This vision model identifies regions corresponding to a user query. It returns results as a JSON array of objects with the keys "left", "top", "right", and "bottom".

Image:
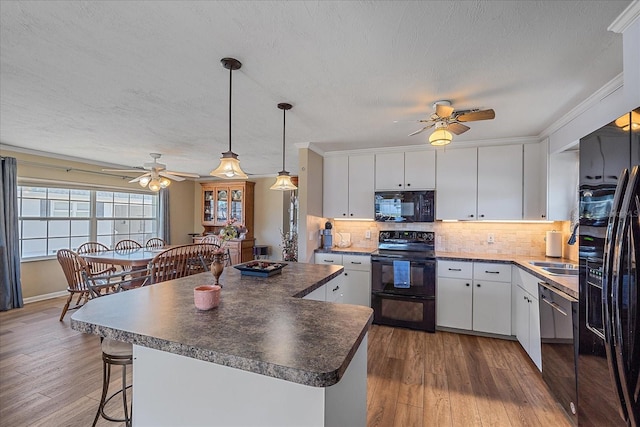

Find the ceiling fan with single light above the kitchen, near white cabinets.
[{"left": 409, "top": 101, "right": 496, "bottom": 145}]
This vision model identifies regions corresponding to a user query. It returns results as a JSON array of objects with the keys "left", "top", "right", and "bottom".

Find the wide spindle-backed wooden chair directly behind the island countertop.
[{"left": 149, "top": 243, "right": 220, "bottom": 283}]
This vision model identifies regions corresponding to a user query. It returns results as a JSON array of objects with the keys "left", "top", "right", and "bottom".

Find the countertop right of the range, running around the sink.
[{"left": 436, "top": 252, "right": 578, "bottom": 299}]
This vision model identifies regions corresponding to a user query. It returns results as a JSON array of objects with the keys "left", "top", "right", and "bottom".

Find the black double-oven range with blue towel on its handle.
[{"left": 371, "top": 231, "right": 436, "bottom": 332}]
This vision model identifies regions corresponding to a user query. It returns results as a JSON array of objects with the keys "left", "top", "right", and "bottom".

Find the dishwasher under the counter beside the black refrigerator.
[{"left": 538, "top": 282, "right": 578, "bottom": 424}]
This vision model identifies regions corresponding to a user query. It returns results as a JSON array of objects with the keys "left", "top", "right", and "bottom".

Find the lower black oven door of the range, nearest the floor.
[{"left": 371, "top": 292, "right": 436, "bottom": 332}]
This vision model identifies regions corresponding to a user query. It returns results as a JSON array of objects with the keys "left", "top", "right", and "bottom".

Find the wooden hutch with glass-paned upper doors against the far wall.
[{"left": 193, "top": 181, "right": 256, "bottom": 264}]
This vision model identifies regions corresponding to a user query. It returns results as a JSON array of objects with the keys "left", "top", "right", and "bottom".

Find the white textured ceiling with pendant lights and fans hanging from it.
[{"left": 0, "top": 0, "right": 630, "bottom": 175}]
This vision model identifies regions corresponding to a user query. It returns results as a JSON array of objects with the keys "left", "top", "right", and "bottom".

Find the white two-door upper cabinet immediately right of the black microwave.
[{"left": 436, "top": 144, "right": 523, "bottom": 220}]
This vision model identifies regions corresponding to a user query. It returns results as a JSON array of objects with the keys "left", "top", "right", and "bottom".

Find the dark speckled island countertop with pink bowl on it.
[{"left": 71, "top": 263, "right": 373, "bottom": 387}]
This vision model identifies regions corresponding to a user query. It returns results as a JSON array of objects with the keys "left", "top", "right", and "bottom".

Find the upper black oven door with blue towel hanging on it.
[{"left": 371, "top": 258, "right": 436, "bottom": 298}]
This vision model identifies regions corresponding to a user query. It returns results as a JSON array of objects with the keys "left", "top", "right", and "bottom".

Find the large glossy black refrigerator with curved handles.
[{"left": 576, "top": 108, "right": 640, "bottom": 426}]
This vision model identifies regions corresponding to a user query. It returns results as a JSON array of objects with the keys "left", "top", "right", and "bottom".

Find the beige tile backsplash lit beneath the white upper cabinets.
[{"left": 333, "top": 221, "right": 578, "bottom": 260}]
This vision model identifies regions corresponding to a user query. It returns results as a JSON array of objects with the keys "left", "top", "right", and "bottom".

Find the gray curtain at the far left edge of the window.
[{"left": 0, "top": 157, "right": 24, "bottom": 311}]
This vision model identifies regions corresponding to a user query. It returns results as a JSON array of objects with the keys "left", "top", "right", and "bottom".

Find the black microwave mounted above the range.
[{"left": 375, "top": 191, "right": 435, "bottom": 223}]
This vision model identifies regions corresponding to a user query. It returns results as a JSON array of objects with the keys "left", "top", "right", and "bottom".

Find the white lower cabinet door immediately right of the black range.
[{"left": 436, "top": 277, "right": 473, "bottom": 330}]
